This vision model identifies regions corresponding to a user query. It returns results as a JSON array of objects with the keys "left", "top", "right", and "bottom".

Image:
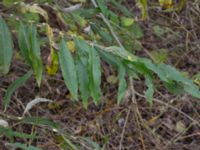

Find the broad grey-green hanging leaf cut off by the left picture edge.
[{"left": 0, "top": 17, "right": 13, "bottom": 75}]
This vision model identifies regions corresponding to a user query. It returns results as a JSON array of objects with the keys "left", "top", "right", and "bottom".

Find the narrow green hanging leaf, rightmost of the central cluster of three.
[{"left": 89, "top": 47, "right": 101, "bottom": 104}]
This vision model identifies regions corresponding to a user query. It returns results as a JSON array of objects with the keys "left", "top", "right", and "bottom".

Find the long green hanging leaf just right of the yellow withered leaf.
[{"left": 58, "top": 40, "right": 78, "bottom": 100}]
